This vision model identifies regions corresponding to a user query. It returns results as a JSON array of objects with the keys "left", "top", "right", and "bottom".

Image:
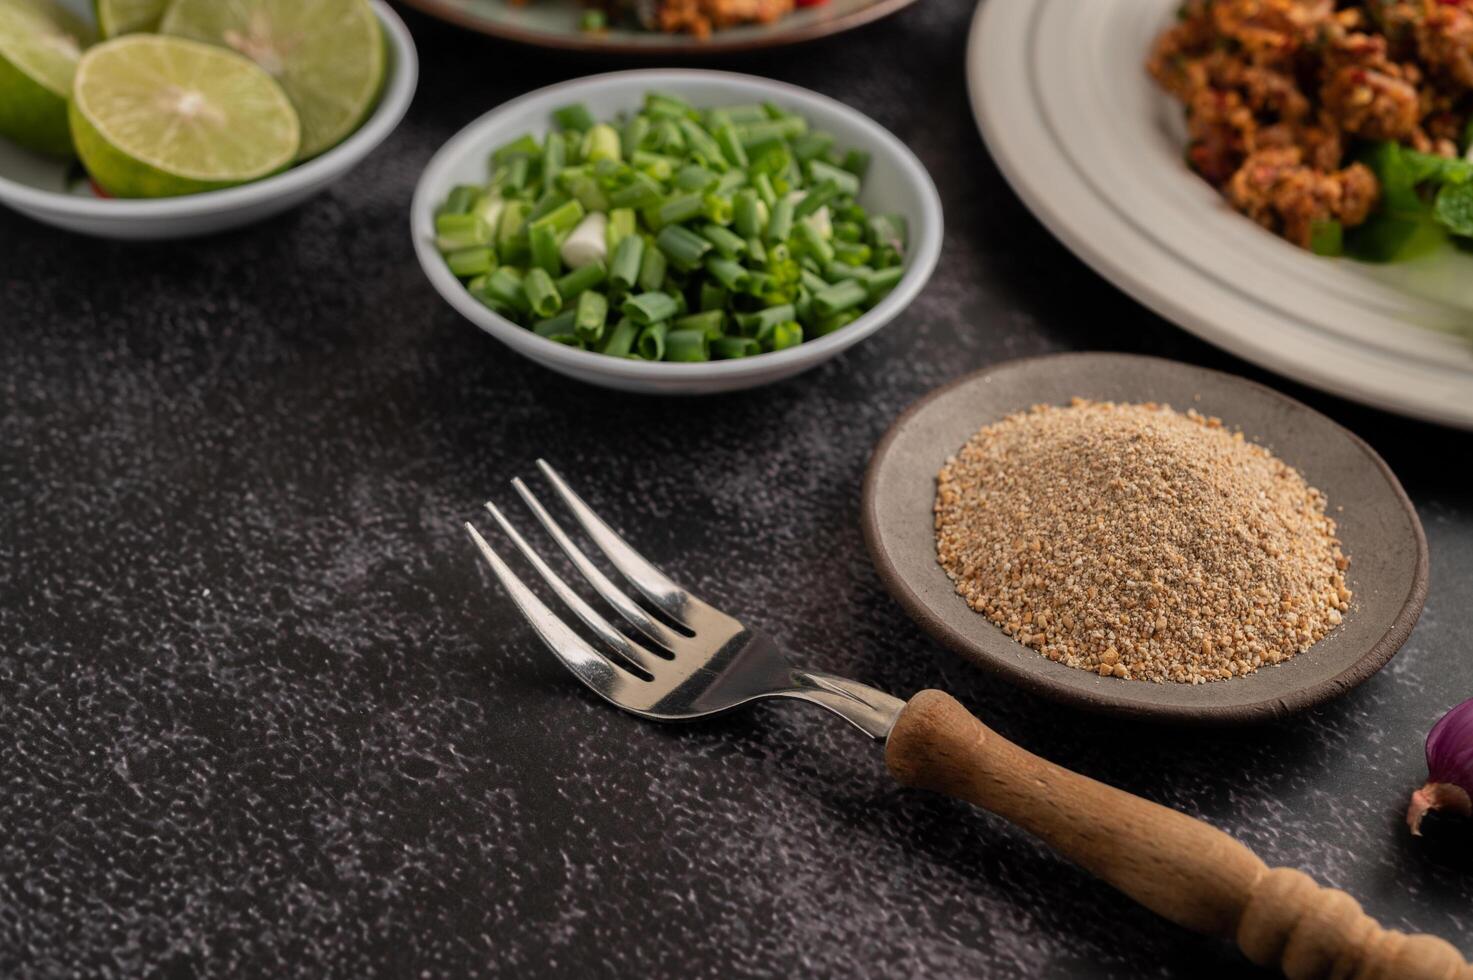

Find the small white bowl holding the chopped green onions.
[{"left": 409, "top": 69, "right": 941, "bottom": 395}]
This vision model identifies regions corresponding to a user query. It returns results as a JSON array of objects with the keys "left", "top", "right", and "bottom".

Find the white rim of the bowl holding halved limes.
[{"left": 0, "top": 0, "right": 420, "bottom": 220}]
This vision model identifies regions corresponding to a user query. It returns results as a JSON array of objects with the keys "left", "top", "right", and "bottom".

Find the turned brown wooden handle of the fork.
[{"left": 885, "top": 691, "right": 1473, "bottom": 980}]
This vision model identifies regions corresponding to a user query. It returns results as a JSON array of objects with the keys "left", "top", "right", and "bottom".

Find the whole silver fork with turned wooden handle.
[{"left": 465, "top": 460, "right": 1473, "bottom": 980}]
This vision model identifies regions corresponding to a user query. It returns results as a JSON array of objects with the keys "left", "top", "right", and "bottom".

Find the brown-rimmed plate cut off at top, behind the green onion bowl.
[{"left": 405, "top": 0, "right": 915, "bottom": 57}]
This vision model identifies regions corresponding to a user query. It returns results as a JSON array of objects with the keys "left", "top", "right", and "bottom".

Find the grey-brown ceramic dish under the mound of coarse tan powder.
[{"left": 862, "top": 354, "right": 1427, "bottom": 724}]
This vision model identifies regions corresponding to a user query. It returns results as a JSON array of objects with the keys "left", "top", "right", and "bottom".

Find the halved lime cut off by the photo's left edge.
[{"left": 0, "top": 0, "right": 93, "bottom": 156}]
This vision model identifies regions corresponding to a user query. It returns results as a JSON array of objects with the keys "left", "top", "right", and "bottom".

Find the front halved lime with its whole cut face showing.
[{"left": 71, "top": 34, "right": 302, "bottom": 197}]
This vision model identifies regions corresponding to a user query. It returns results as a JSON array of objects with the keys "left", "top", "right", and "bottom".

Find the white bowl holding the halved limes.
[{"left": 0, "top": 0, "right": 420, "bottom": 239}]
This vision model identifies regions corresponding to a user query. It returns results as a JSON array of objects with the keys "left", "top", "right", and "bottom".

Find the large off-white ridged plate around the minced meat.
[{"left": 966, "top": 0, "right": 1473, "bottom": 429}]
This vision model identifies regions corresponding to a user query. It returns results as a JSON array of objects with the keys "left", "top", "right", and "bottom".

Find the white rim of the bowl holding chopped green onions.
[{"left": 409, "top": 68, "right": 944, "bottom": 380}]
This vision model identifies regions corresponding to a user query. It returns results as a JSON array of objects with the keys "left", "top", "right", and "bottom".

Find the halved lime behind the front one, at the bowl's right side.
[{"left": 161, "top": 0, "right": 387, "bottom": 159}]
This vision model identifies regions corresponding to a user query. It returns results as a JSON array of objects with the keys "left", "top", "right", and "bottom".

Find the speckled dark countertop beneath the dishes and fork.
[{"left": 0, "top": 0, "right": 1473, "bottom": 977}]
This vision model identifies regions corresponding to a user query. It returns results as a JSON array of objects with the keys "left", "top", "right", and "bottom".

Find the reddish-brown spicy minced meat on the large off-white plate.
[{"left": 1147, "top": 0, "right": 1473, "bottom": 258}]
